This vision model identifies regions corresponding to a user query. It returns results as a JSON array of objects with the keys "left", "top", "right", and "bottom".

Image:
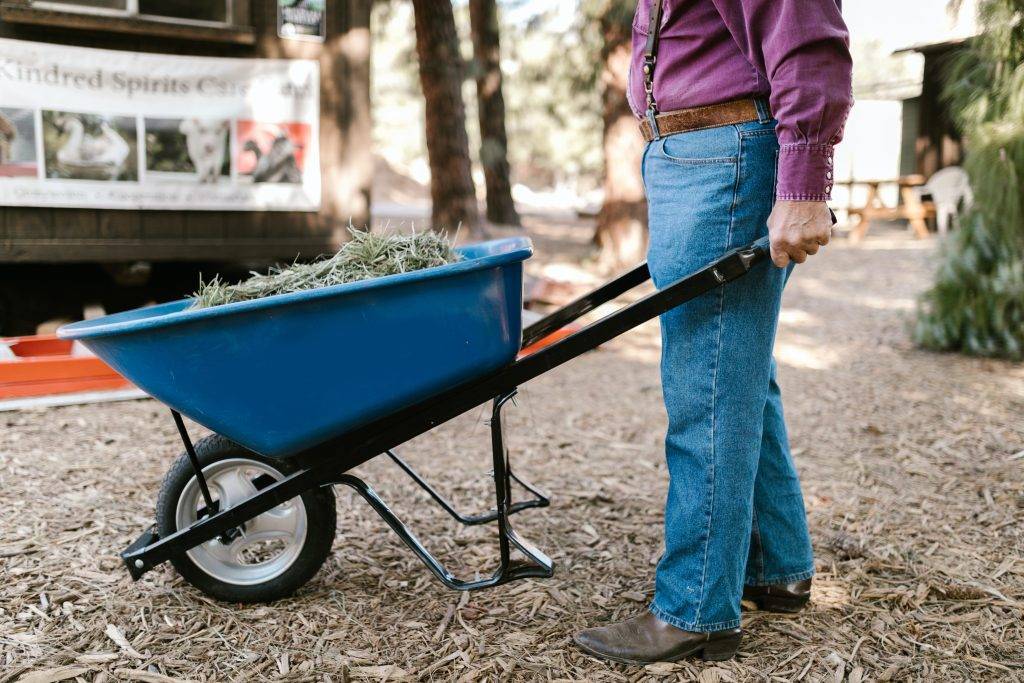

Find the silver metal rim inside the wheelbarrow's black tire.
[{"left": 175, "top": 458, "right": 307, "bottom": 586}]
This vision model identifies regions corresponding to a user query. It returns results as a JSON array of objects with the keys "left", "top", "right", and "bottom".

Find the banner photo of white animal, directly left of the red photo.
[{"left": 144, "top": 119, "right": 231, "bottom": 183}]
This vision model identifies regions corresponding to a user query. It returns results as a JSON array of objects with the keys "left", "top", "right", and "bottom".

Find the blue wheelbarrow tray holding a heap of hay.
[{"left": 58, "top": 238, "right": 532, "bottom": 457}]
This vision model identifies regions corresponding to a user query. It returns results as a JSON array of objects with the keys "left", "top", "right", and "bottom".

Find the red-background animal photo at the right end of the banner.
[{"left": 236, "top": 121, "right": 309, "bottom": 184}]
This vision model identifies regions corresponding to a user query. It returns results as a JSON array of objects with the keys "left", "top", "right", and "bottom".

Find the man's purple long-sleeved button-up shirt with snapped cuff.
[{"left": 629, "top": 0, "right": 853, "bottom": 201}]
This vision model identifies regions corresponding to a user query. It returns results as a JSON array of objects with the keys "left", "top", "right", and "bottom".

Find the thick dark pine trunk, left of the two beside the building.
[{"left": 413, "top": 0, "right": 479, "bottom": 234}]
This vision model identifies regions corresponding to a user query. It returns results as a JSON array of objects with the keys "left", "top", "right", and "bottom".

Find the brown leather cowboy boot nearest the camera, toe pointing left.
[{"left": 573, "top": 611, "right": 743, "bottom": 665}]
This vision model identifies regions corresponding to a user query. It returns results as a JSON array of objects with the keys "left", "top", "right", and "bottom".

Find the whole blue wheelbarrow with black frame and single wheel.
[{"left": 58, "top": 238, "right": 768, "bottom": 602}]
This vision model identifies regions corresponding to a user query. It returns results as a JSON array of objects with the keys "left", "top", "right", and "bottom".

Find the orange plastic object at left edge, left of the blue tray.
[{"left": 0, "top": 335, "right": 131, "bottom": 399}]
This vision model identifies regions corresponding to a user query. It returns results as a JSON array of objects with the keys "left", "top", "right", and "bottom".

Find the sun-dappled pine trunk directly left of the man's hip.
[{"left": 594, "top": 12, "right": 647, "bottom": 269}]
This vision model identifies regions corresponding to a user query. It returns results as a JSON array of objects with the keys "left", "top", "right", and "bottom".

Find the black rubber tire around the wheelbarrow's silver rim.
[{"left": 157, "top": 434, "right": 337, "bottom": 603}]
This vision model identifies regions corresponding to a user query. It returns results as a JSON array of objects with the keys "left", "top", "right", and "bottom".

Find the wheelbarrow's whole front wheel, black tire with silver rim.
[{"left": 157, "top": 434, "right": 337, "bottom": 602}]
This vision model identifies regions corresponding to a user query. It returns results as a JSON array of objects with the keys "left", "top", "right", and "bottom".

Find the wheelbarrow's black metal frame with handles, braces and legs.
[{"left": 121, "top": 240, "right": 768, "bottom": 591}]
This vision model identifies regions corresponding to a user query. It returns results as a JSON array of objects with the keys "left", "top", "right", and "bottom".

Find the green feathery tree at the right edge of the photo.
[{"left": 914, "top": 0, "right": 1024, "bottom": 359}]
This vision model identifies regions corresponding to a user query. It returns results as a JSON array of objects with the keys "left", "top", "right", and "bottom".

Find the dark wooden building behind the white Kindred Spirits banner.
[{"left": 0, "top": 0, "right": 372, "bottom": 264}]
